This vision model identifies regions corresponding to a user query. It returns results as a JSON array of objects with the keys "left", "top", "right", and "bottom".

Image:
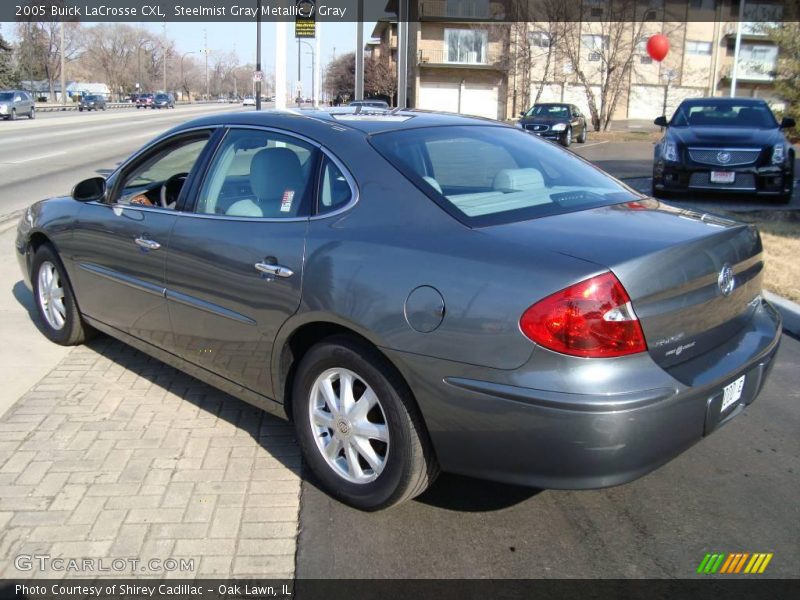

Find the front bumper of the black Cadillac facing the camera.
[{"left": 653, "top": 163, "right": 793, "bottom": 195}]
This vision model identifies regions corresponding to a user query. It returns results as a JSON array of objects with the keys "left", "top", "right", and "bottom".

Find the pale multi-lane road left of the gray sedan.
[{"left": 0, "top": 104, "right": 252, "bottom": 217}]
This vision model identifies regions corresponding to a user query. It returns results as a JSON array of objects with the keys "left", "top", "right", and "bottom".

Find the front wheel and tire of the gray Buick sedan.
[{"left": 31, "top": 244, "right": 92, "bottom": 346}]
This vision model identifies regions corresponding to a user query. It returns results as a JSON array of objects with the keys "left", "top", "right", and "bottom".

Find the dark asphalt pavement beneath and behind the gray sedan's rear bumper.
[{"left": 297, "top": 337, "right": 800, "bottom": 579}]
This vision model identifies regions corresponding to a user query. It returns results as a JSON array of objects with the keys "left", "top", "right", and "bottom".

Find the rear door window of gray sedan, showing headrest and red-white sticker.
[{"left": 196, "top": 129, "right": 317, "bottom": 219}]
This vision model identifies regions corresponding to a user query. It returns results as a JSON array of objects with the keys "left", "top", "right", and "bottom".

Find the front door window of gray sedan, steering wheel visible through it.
[{"left": 112, "top": 132, "right": 210, "bottom": 209}]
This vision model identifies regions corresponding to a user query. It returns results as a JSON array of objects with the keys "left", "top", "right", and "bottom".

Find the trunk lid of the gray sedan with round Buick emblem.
[{"left": 484, "top": 200, "right": 763, "bottom": 368}]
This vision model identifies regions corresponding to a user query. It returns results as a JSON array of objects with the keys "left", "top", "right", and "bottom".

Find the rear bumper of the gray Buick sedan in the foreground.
[{"left": 387, "top": 301, "right": 780, "bottom": 489}]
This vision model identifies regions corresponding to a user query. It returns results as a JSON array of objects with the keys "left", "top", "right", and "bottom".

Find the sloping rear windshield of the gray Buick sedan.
[{"left": 370, "top": 126, "right": 639, "bottom": 227}]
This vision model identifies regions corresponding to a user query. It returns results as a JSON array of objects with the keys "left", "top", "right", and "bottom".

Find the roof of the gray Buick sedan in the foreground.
[{"left": 177, "top": 108, "right": 510, "bottom": 135}]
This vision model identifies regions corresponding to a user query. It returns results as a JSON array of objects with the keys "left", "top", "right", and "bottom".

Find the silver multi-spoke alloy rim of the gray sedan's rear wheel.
[{"left": 308, "top": 368, "right": 390, "bottom": 484}]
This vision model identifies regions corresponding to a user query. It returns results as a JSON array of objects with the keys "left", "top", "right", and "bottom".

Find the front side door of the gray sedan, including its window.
[{"left": 71, "top": 129, "right": 217, "bottom": 349}]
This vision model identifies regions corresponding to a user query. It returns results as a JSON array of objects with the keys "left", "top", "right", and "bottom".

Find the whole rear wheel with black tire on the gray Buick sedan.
[{"left": 292, "top": 336, "right": 439, "bottom": 510}]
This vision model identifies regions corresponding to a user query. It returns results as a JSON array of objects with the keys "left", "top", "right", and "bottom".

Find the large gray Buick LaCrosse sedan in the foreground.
[{"left": 15, "top": 111, "right": 781, "bottom": 509}]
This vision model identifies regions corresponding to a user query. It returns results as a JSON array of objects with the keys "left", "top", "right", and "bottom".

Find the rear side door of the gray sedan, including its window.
[{"left": 167, "top": 128, "right": 319, "bottom": 397}]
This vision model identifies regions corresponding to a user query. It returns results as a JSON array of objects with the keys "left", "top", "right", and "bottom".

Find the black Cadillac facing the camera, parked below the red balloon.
[{"left": 653, "top": 98, "right": 795, "bottom": 203}]
